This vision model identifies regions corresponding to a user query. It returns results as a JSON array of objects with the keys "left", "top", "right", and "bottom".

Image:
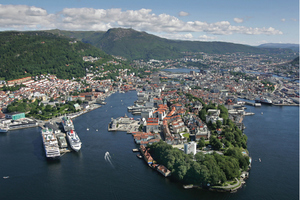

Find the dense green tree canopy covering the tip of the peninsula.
[{"left": 149, "top": 141, "right": 249, "bottom": 186}]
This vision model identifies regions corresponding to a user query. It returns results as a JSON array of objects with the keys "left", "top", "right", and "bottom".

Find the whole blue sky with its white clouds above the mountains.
[{"left": 0, "top": 0, "right": 299, "bottom": 45}]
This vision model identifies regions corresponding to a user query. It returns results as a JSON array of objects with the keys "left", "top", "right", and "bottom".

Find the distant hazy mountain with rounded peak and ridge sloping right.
[{"left": 50, "top": 28, "right": 289, "bottom": 60}]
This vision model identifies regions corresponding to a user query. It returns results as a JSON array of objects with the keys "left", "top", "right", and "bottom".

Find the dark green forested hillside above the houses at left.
[{"left": 0, "top": 31, "right": 112, "bottom": 80}]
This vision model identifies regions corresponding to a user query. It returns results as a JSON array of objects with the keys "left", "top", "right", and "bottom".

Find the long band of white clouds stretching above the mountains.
[{"left": 0, "top": 4, "right": 283, "bottom": 36}]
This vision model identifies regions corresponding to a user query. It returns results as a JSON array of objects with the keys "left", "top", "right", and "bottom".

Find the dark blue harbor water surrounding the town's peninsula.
[{"left": 0, "top": 91, "right": 299, "bottom": 200}]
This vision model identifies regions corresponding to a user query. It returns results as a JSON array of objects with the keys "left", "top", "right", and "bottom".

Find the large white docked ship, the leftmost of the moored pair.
[{"left": 41, "top": 128, "right": 60, "bottom": 159}]
